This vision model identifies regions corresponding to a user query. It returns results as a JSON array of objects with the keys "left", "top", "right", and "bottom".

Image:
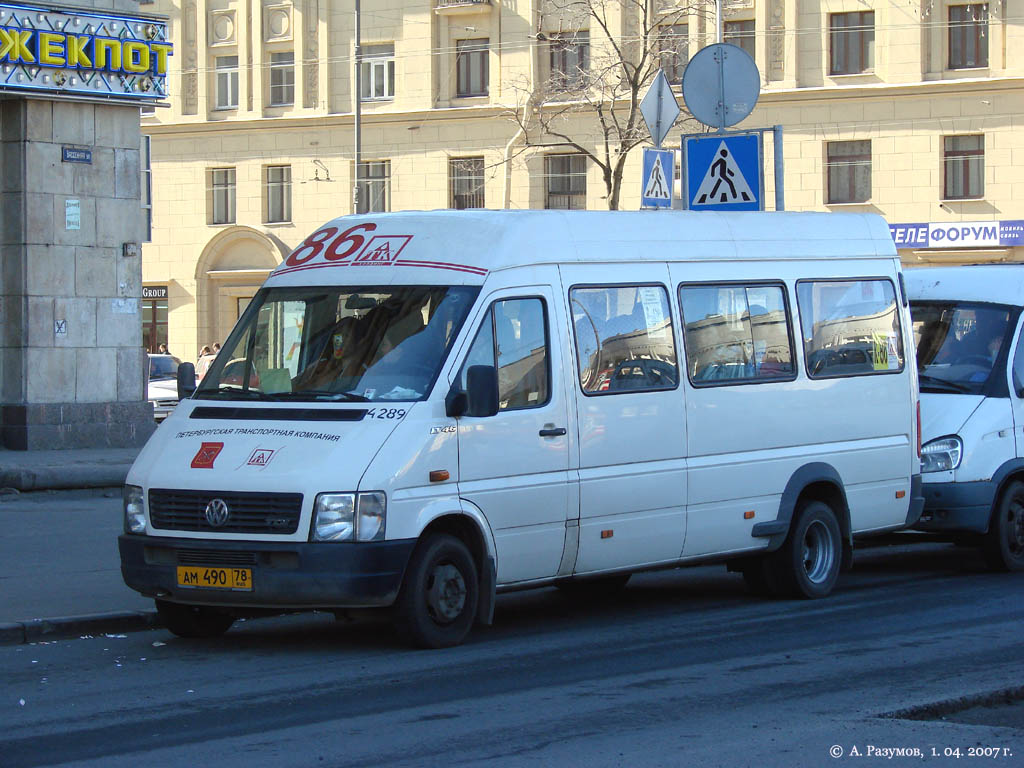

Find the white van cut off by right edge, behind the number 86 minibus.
[{"left": 906, "top": 264, "right": 1024, "bottom": 570}]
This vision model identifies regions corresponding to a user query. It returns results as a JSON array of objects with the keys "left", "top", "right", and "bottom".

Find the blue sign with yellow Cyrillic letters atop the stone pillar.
[{"left": 0, "top": 3, "right": 173, "bottom": 100}]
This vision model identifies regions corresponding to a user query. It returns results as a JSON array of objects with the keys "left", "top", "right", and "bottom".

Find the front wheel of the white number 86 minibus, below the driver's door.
[{"left": 395, "top": 534, "right": 479, "bottom": 648}]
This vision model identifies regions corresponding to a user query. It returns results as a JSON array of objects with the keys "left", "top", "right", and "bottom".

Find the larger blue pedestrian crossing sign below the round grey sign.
[{"left": 683, "top": 132, "right": 764, "bottom": 211}]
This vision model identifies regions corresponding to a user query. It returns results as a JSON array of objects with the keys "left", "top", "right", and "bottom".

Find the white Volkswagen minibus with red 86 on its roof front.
[{"left": 120, "top": 211, "right": 922, "bottom": 647}]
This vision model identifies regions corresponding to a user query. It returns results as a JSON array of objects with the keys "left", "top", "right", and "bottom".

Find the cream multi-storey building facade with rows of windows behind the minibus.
[{"left": 142, "top": 0, "right": 1024, "bottom": 359}]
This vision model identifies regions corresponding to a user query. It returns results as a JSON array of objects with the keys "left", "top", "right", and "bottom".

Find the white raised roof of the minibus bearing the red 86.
[{"left": 269, "top": 210, "right": 896, "bottom": 286}]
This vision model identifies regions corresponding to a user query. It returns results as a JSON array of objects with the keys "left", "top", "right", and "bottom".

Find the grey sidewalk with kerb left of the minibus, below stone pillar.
[{"left": 0, "top": 449, "right": 156, "bottom": 645}]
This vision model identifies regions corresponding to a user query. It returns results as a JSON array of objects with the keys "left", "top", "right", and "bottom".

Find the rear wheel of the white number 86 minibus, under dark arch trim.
[{"left": 768, "top": 501, "right": 843, "bottom": 600}]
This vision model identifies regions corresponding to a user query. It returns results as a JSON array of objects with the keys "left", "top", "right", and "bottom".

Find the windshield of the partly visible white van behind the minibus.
[{"left": 910, "top": 301, "right": 1016, "bottom": 394}]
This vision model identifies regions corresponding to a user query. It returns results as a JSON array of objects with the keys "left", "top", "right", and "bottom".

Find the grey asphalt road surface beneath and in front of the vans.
[{"left": 0, "top": 545, "right": 1024, "bottom": 768}]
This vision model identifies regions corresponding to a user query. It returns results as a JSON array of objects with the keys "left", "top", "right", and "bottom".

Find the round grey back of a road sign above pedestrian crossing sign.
[{"left": 683, "top": 43, "right": 761, "bottom": 130}]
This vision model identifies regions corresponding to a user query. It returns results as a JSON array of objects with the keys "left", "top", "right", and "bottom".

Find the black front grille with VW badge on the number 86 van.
[{"left": 150, "top": 488, "right": 302, "bottom": 534}]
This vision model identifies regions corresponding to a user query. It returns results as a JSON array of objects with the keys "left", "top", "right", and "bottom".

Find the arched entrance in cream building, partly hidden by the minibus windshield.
[{"left": 196, "top": 226, "right": 288, "bottom": 350}]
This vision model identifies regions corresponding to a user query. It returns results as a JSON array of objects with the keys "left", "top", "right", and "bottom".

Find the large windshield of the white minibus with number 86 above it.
[{"left": 196, "top": 286, "right": 479, "bottom": 401}]
